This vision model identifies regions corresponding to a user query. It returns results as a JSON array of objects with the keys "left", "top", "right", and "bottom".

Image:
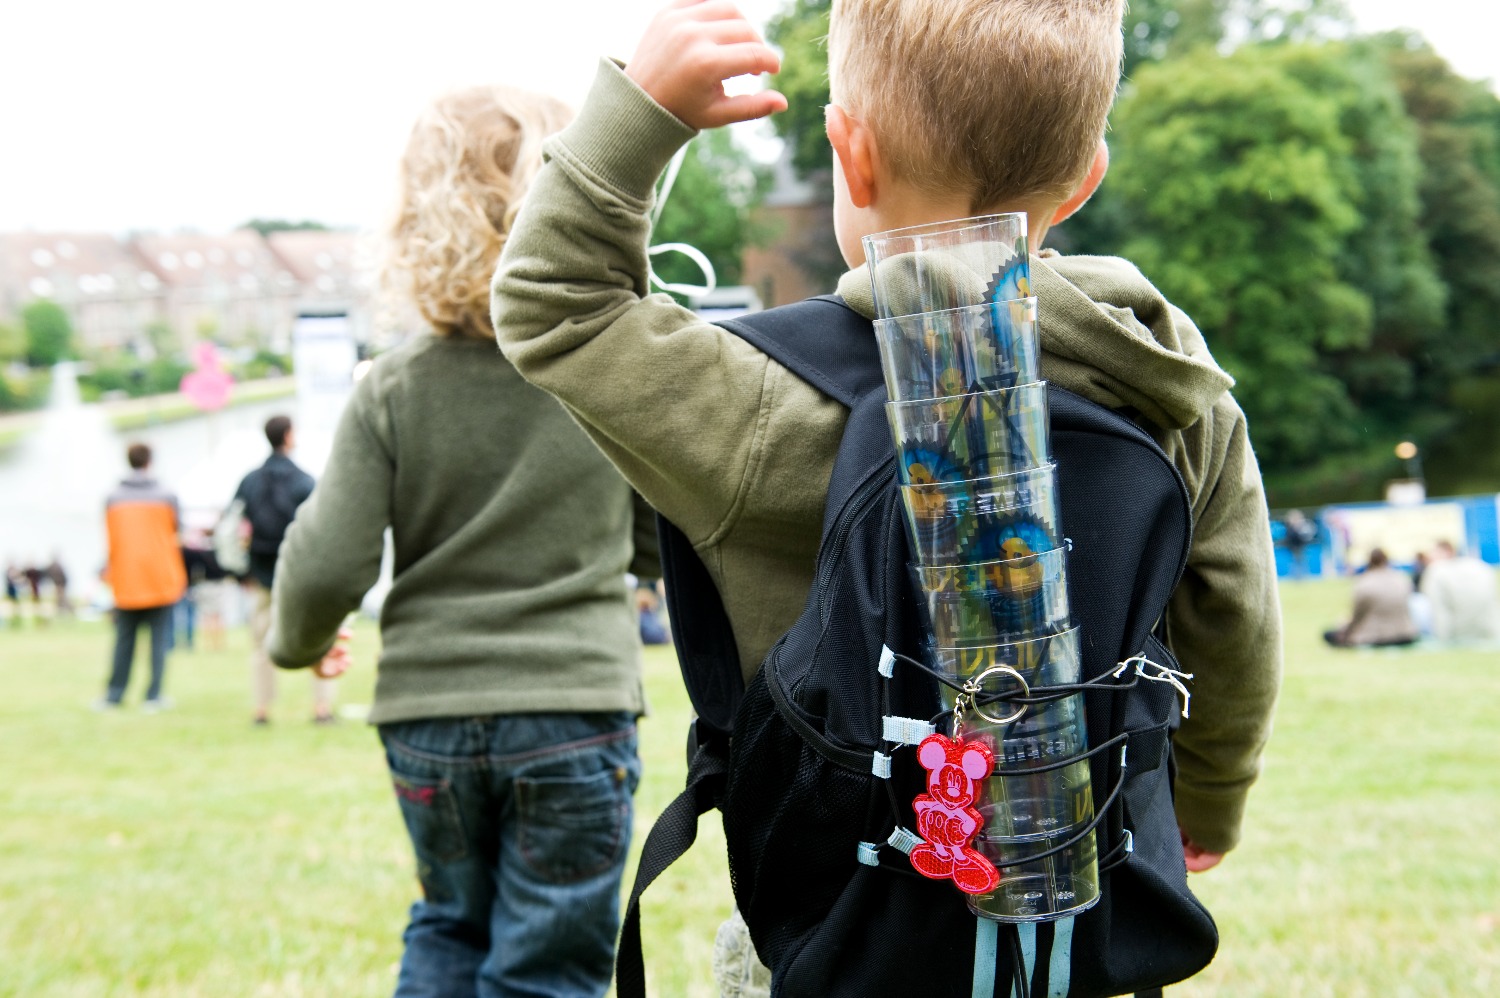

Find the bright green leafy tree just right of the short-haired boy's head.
[{"left": 1109, "top": 44, "right": 1445, "bottom": 498}]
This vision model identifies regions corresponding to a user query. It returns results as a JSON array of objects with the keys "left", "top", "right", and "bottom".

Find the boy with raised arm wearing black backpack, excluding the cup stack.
[{"left": 492, "top": 0, "right": 1281, "bottom": 998}]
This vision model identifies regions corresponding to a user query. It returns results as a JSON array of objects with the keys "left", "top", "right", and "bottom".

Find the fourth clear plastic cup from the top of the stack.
[{"left": 902, "top": 464, "right": 1062, "bottom": 566}]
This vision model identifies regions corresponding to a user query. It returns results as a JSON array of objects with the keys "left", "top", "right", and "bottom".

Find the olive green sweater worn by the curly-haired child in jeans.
[{"left": 269, "top": 336, "right": 659, "bottom": 723}]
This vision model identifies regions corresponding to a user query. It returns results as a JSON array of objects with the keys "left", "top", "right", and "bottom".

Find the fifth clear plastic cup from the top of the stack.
[{"left": 915, "top": 548, "right": 1071, "bottom": 648}]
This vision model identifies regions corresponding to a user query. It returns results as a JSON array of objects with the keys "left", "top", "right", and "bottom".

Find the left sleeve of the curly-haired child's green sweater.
[{"left": 267, "top": 373, "right": 395, "bottom": 669}]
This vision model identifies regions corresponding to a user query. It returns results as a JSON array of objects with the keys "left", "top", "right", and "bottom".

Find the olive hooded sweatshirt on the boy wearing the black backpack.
[{"left": 494, "top": 62, "right": 1281, "bottom": 851}]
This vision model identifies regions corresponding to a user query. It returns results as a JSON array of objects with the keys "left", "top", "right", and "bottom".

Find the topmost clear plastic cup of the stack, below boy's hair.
[{"left": 863, "top": 213, "right": 1031, "bottom": 318}]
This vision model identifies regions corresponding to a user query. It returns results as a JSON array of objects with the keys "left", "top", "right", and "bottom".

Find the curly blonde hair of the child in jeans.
[{"left": 380, "top": 86, "right": 573, "bottom": 339}]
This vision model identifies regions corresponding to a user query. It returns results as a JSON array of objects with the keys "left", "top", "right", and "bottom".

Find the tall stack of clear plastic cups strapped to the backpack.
[{"left": 864, "top": 215, "right": 1100, "bottom": 921}]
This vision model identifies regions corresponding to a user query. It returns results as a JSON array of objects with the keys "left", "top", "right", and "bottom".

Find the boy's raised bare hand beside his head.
[{"left": 626, "top": 0, "right": 786, "bottom": 129}]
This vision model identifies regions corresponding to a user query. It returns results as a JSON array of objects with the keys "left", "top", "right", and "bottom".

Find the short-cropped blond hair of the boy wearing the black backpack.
[{"left": 828, "top": 0, "right": 1125, "bottom": 213}]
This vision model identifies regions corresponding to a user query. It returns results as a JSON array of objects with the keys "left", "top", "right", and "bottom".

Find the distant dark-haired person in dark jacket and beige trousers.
[{"left": 231, "top": 416, "right": 333, "bottom": 725}]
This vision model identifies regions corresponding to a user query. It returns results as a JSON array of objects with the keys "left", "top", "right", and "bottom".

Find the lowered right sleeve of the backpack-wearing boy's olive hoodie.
[{"left": 1167, "top": 395, "right": 1281, "bottom": 852}]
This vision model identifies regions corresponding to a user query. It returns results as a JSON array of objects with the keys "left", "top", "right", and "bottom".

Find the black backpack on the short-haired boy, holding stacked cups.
[{"left": 617, "top": 297, "right": 1218, "bottom": 998}]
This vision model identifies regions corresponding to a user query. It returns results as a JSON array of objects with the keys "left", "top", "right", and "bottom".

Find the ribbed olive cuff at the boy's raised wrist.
[{"left": 548, "top": 59, "right": 698, "bottom": 203}]
